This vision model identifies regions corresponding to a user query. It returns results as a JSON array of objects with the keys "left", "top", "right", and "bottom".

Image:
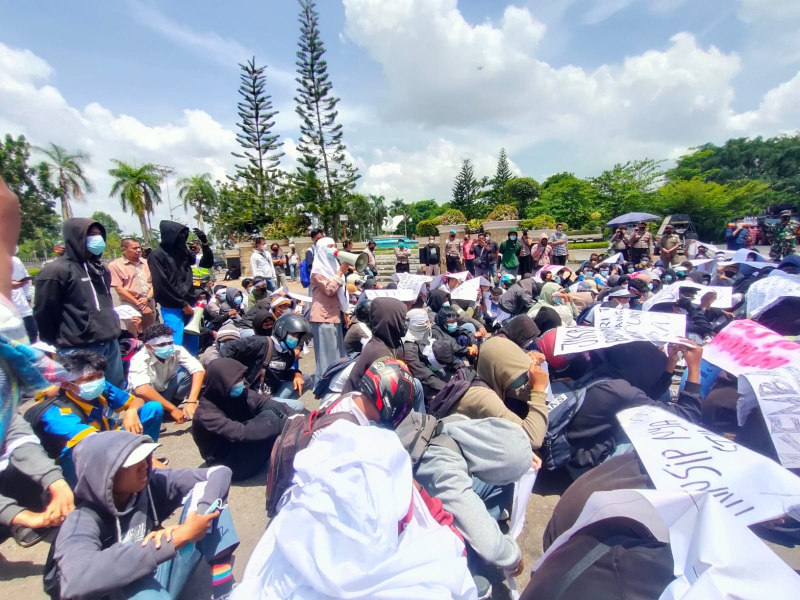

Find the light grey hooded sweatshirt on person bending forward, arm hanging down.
[{"left": 416, "top": 417, "right": 533, "bottom": 568}]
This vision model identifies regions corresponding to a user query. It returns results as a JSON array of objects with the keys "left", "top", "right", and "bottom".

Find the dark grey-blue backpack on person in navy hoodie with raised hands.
[{"left": 542, "top": 378, "right": 608, "bottom": 471}]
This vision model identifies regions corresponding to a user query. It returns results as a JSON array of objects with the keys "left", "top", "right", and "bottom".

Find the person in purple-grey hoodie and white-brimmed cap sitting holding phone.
[{"left": 53, "top": 431, "right": 238, "bottom": 598}]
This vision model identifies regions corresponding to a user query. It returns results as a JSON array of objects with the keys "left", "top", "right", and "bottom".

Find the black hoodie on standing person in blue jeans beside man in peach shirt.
[{"left": 147, "top": 221, "right": 214, "bottom": 309}]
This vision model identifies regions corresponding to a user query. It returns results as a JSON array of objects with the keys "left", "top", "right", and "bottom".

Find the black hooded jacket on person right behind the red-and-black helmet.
[{"left": 344, "top": 298, "right": 408, "bottom": 393}]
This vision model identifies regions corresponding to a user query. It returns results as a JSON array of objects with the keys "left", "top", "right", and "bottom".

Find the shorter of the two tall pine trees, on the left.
[{"left": 232, "top": 57, "right": 284, "bottom": 204}]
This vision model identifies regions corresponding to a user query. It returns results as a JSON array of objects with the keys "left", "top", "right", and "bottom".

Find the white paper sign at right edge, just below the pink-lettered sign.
[{"left": 736, "top": 367, "right": 800, "bottom": 469}]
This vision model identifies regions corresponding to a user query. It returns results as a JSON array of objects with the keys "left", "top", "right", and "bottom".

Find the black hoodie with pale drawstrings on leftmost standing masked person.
[{"left": 33, "top": 219, "right": 120, "bottom": 348}]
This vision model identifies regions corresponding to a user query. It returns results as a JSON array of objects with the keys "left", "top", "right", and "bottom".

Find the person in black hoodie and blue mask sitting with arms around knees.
[{"left": 192, "top": 358, "right": 294, "bottom": 481}]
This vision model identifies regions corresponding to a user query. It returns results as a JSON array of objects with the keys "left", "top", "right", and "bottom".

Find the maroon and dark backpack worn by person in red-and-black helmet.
[{"left": 267, "top": 410, "right": 359, "bottom": 518}]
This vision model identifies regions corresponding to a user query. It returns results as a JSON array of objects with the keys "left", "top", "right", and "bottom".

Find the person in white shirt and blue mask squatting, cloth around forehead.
[{"left": 129, "top": 323, "right": 205, "bottom": 422}]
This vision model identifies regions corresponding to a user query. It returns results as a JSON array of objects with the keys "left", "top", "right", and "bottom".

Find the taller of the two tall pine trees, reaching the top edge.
[{"left": 295, "top": 0, "right": 359, "bottom": 239}]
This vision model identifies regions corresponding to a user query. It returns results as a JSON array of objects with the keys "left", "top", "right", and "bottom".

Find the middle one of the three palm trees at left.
[{"left": 108, "top": 159, "right": 164, "bottom": 245}]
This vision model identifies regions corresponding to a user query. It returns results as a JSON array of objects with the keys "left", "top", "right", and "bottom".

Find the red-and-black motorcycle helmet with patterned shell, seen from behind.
[{"left": 360, "top": 358, "right": 414, "bottom": 429}]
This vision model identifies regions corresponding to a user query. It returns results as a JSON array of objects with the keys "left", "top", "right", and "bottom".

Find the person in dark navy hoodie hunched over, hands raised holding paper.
[{"left": 567, "top": 340, "right": 703, "bottom": 478}]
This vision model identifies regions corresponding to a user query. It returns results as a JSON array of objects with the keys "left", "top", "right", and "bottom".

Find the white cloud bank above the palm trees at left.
[{"left": 0, "top": 43, "right": 237, "bottom": 232}]
